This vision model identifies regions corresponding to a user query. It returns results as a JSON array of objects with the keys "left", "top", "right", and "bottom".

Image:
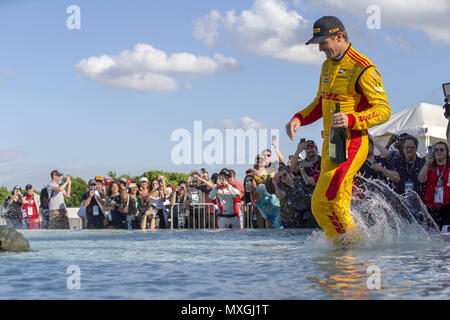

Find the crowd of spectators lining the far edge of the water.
[{"left": 1, "top": 133, "right": 450, "bottom": 230}]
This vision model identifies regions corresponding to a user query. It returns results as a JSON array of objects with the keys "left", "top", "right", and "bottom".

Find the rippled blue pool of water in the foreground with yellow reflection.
[{"left": 0, "top": 229, "right": 450, "bottom": 300}]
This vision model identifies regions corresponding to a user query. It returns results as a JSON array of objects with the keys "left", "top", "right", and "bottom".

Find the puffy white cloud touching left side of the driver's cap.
[{"left": 193, "top": 0, "right": 324, "bottom": 64}]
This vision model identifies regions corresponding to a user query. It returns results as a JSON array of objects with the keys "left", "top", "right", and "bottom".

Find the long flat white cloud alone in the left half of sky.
[{"left": 75, "top": 43, "right": 242, "bottom": 91}]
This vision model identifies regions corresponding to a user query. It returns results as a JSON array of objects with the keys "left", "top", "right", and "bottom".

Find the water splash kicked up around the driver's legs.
[{"left": 306, "top": 177, "right": 439, "bottom": 250}]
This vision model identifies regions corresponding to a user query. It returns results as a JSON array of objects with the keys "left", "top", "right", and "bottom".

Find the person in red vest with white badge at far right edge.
[{"left": 418, "top": 142, "right": 450, "bottom": 229}]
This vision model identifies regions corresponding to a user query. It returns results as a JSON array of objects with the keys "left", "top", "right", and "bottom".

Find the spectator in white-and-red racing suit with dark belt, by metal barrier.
[{"left": 209, "top": 170, "right": 241, "bottom": 229}]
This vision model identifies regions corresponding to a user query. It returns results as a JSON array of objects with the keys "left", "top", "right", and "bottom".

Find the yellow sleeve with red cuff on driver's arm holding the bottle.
[{"left": 347, "top": 66, "right": 391, "bottom": 130}]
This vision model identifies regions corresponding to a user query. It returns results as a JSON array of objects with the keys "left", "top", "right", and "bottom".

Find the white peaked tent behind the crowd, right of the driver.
[{"left": 369, "top": 102, "right": 448, "bottom": 157}]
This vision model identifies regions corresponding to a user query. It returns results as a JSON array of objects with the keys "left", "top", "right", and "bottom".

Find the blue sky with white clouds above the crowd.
[{"left": 0, "top": 0, "right": 450, "bottom": 188}]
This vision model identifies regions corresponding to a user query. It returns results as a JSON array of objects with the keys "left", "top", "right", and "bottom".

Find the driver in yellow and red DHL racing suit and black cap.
[{"left": 286, "top": 16, "right": 391, "bottom": 244}]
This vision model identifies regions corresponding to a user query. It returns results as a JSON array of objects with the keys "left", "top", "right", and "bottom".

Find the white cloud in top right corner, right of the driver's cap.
[{"left": 313, "top": 0, "right": 450, "bottom": 44}]
